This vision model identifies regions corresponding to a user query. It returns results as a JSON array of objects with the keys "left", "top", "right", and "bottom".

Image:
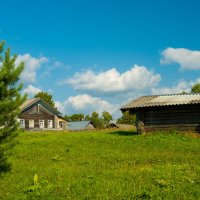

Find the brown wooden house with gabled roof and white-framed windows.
[{"left": 18, "top": 98, "right": 67, "bottom": 130}]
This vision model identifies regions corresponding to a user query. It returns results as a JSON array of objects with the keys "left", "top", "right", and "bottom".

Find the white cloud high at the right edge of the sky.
[{"left": 160, "top": 47, "right": 200, "bottom": 70}]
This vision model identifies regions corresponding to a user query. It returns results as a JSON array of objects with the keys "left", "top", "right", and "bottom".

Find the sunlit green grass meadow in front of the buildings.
[{"left": 0, "top": 131, "right": 200, "bottom": 200}]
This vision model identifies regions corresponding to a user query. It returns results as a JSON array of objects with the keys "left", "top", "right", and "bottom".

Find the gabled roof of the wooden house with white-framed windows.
[{"left": 20, "top": 98, "right": 61, "bottom": 115}]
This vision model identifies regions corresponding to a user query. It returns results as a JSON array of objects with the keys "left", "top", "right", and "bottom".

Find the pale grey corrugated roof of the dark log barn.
[{"left": 121, "top": 94, "right": 200, "bottom": 110}]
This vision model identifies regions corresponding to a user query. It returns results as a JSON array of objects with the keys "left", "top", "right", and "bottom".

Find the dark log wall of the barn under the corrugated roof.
[{"left": 134, "top": 105, "right": 200, "bottom": 133}]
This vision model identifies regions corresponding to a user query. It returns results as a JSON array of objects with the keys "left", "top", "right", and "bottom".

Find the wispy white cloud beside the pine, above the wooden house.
[{"left": 16, "top": 53, "right": 48, "bottom": 83}]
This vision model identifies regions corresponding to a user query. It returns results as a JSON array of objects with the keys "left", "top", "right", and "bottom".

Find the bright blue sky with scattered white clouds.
[{"left": 0, "top": 0, "right": 200, "bottom": 116}]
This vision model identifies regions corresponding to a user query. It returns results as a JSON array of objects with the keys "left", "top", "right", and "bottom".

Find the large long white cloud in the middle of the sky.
[{"left": 62, "top": 65, "right": 161, "bottom": 93}]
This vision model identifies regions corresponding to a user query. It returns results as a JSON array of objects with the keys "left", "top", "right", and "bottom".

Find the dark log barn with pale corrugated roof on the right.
[{"left": 121, "top": 94, "right": 200, "bottom": 133}]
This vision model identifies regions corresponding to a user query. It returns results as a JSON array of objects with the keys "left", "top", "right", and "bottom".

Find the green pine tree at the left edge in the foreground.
[{"left": 0, "top": 42, "right": 26, "bottom": 172}]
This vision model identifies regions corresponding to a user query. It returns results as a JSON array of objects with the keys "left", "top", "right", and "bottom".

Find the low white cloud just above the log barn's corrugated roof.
[{"left": 152, "top": 78, "right": 200, "bottom": 94}]
